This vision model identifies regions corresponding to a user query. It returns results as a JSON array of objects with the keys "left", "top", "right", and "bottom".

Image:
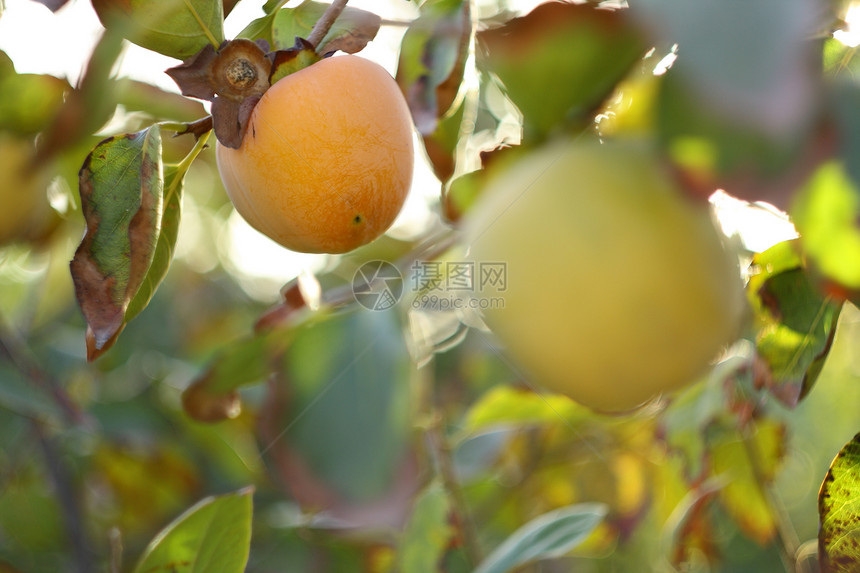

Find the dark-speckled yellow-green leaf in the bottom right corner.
[{"left": 818, "top": 434, "right": 860, "bottom": 573}]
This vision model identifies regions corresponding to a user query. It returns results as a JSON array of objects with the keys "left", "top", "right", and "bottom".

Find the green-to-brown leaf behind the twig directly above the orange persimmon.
[{"left": 272, "top": 2, "right": 382, "bottom": 54}]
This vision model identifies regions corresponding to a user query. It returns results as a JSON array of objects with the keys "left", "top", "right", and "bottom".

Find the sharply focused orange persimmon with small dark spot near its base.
[{"left": 216, "top": 56, "right": 414, "bottom": 253}]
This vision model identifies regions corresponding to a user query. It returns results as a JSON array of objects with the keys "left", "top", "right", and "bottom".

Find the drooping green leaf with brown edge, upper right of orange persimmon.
[{"left": 395, "top": 0, "right": 472, "bottom": 136}]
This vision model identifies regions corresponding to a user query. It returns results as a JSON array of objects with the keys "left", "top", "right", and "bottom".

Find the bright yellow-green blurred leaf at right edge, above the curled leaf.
[{"left": 791, "top": 162, "right": 860, "bottom": 289}]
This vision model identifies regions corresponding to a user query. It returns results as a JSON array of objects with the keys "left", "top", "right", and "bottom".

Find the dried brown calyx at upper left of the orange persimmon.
[{"left": 167, "top": 39, "right": 272, "bottom": 149}]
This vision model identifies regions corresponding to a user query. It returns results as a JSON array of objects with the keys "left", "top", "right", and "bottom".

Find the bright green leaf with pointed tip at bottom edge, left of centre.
[{"left": 134, "top": 488, "right": 253, "bottom": 573}]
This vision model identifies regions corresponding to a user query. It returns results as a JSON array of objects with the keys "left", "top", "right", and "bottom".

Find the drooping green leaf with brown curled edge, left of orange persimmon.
[{"left": 70, "top": 125, "right": 164, "bottom": 360}]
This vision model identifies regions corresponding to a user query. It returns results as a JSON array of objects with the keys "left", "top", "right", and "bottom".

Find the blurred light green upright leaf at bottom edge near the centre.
[{"left": 398, "top": 481, "right": 452, "bottom": 573}]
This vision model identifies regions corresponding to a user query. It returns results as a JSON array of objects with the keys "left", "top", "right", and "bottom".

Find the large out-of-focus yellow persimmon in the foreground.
[{"left": 464, "top": 142, "right": 744, "bottom": 412}]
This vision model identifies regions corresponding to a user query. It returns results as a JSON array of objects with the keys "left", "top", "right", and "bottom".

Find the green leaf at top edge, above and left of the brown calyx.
[{"left": 93, "top": 0, "right": 224, "bottom": 60}]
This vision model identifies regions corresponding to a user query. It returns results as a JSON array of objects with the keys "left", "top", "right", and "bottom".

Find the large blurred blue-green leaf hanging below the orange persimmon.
[{"left": 269, "top": 310, "right": 412, "bottom": 502}]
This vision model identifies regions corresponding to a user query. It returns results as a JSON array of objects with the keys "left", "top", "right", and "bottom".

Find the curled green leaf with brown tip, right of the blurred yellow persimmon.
[{"left": 749, "top": 243, "right": 842, "bottom": 407}]
